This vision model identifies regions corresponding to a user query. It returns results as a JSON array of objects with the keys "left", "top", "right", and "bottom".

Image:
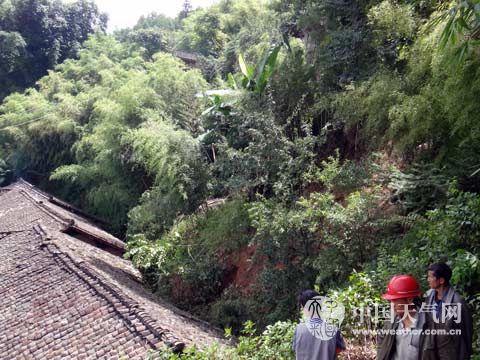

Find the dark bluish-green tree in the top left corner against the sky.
[{"left": 0, "top": 0, "right": 107, "bottom": 99}]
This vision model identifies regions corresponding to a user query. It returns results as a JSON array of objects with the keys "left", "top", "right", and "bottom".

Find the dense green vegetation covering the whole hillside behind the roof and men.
[{"left": 0, "top": 0, "right": 480, "bottom": 359}]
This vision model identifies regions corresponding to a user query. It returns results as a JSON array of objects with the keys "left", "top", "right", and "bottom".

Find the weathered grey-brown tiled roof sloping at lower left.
[{"left": 0, "top": 181, "right": 227, "bottom": 360}]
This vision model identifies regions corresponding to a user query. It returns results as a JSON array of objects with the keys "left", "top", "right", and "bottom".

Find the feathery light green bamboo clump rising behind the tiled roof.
[{"left": 0, "top": 35, "right": 205, "bottom": 233}]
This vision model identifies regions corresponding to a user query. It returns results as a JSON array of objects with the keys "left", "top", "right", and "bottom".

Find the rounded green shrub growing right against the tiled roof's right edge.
[{"left": 126, "top": 197, "right": 250, "bottom": 314}]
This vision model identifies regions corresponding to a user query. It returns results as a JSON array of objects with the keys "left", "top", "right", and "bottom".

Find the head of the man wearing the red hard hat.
[{"left": 382, "top": 275, "right": 421, "bottom": 317}]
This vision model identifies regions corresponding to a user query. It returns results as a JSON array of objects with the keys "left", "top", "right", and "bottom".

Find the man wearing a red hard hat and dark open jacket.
[{"left": 377, "top": 275, "right": 423, "bottom": 360}]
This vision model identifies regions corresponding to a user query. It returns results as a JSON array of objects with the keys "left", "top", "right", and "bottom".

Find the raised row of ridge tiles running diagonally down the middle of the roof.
[{"left": 34, "top": 225, "right": 185, "bottom": 352}]
